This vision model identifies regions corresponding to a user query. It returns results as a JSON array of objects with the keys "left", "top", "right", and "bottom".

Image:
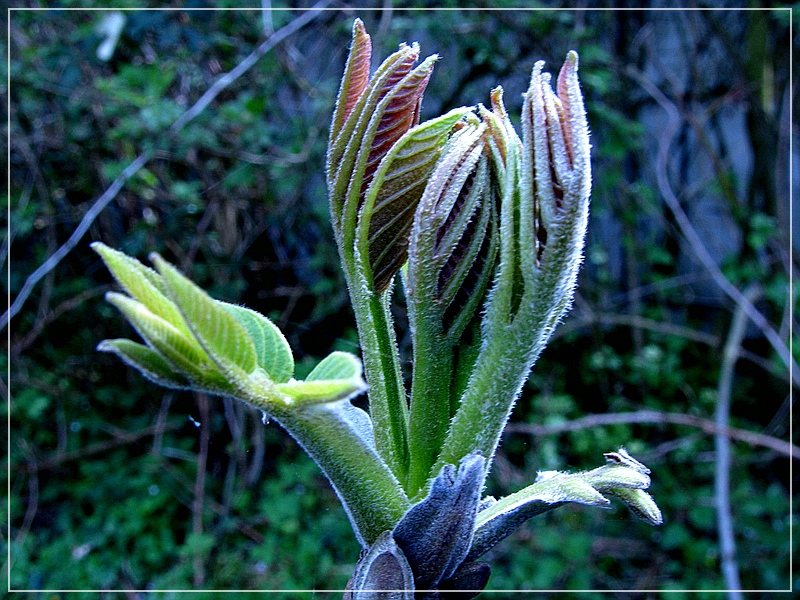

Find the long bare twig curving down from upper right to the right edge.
[{"left": 628, "top": 68, "right": 800, "bottom": 387}]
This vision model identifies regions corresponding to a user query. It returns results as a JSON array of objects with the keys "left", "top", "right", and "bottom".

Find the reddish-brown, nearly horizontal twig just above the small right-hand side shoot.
[{"left": 506, "top": 410, "right": 800, "bottom": 460}]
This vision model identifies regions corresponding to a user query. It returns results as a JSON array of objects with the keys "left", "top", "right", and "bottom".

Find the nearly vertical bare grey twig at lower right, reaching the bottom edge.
[{"left": 714, "top": 285, "right": 758, "bottom": 600}]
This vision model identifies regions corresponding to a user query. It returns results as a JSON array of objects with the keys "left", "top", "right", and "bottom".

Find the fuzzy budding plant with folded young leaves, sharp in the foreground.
[{"left": 94, "top": 20, "right": 661, "bottom": 598}]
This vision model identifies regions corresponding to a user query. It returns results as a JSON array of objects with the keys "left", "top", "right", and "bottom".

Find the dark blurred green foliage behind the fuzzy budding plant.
[{"left": 0, "top": 0, "right": 800, "bottom": 598}]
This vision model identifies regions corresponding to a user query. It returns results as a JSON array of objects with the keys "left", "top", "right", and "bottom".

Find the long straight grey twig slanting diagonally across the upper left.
[{"left": 0, "top": 0, "right": 330, "bottom": 330}]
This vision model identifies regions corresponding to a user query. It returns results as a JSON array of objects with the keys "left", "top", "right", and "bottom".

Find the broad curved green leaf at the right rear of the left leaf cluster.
[{"left": 222, "top": 301, "right": 294, "bottom": 383}]
